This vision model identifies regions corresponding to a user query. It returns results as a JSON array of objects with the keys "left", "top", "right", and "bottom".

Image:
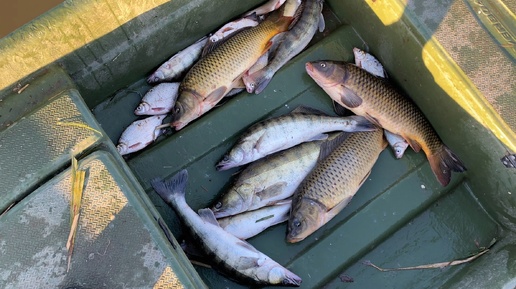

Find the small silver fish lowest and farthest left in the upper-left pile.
[{"left": 116, "top": 114, "right": 166, "bottom": 155}]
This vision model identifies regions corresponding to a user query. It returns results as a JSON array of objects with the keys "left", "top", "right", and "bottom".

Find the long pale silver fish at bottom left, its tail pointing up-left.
[{"left": 151, "top": 170, "right": 302, "bottom": 286}]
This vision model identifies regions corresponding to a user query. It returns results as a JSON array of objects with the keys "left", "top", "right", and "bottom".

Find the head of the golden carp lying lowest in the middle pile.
[{"left": 287, "top": 199, "right": 326, "bottom": 243}]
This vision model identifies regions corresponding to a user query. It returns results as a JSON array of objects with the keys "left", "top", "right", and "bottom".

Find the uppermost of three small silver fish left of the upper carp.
[{"left": 147, "top": 36, "right": 208, "bottom": 84}]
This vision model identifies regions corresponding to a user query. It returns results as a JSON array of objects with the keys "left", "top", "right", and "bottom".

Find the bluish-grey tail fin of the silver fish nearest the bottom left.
[{"left": 151, "top": 170, "right": 188, "bottom": 205}]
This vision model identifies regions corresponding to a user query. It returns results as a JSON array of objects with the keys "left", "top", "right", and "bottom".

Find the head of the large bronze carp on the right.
[{"left": 305, "top": 60, "right": 348, "bottom": 89}]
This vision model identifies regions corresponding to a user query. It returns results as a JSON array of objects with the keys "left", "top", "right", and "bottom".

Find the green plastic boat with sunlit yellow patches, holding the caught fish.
[{"left": 0, "top": 0, "right": 516, "bottom": 289}]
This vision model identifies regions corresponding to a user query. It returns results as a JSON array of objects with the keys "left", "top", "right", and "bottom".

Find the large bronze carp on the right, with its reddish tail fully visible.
[{"left": 306, "top": 61, "right": 466, "bottom": 187}]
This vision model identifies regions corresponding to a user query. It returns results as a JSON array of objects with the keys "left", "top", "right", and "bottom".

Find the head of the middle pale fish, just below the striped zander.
[{"left": 211, "top": 183, "right": 254, "bottom": 219}]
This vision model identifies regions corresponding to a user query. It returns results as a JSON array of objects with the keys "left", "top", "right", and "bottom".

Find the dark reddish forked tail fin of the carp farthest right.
[{"left": 428, "top": 144, "right": 466, "bottom": 187}]
